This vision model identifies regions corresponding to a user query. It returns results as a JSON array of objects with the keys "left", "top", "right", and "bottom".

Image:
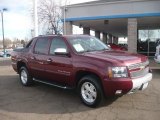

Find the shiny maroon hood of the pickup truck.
[{"left": 83, "top": 51, "right": 148, "bottom": 66}]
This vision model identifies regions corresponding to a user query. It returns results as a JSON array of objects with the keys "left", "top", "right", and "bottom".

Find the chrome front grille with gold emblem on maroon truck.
[{"left": 128, "top": 61, "right": 149, "bottom": 78}]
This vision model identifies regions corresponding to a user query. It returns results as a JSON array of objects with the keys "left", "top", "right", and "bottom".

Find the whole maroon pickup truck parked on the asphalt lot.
[{"left": 11, "top": 35, "right": 152, "bottom": 107}]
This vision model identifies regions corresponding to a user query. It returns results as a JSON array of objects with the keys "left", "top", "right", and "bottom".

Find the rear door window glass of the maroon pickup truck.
[{"left": 34, "top": 38, "right": 49, "bottom": 54}]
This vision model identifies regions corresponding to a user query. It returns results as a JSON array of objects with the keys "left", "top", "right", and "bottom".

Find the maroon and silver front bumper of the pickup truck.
[{"left": 103, "top": 73, "right": 152, "bottom": 96}]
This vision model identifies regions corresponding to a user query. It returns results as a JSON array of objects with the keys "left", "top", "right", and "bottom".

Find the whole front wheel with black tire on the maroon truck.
[{"left": 78, "top": 75, "right": 103, "bottom": 107}]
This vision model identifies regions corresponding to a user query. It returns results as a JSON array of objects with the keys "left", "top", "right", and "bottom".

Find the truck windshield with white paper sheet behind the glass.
[{"left": 69, "top": 36, "right": 110, "bottom": 53}]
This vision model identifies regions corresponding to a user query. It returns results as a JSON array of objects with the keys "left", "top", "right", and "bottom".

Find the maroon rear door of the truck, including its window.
[{"left": 28, "top": 37, "right": 49, "bottom": 79}]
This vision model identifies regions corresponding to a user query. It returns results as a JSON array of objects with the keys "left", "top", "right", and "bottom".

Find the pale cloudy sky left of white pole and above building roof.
[{"left": 0, "top": 0, "right": 94, "bottom": 40}]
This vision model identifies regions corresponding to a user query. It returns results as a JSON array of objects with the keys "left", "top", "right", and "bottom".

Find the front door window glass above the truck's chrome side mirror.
[{"left": 49, "top": 38, "right": 67, "bottom": 55}]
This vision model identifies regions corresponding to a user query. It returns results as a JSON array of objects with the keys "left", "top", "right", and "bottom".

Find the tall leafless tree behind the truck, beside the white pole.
[{"left": 38, "top": 0, "right": 62, "bottom": 34}]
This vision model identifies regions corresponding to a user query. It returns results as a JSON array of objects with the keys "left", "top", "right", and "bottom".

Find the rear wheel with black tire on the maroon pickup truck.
[{"left": 19, "top": 67, "right": 33, "bottom": 86}]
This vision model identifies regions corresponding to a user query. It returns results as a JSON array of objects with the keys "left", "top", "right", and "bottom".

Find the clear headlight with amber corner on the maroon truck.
[{"left": 109, "top": 67, "right": 128, "bottom": 78}]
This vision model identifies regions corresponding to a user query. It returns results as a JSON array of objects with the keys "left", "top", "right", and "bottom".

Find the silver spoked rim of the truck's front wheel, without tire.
[{"left": 81, "top": 82, "right": 97, "bottom": 103}]
